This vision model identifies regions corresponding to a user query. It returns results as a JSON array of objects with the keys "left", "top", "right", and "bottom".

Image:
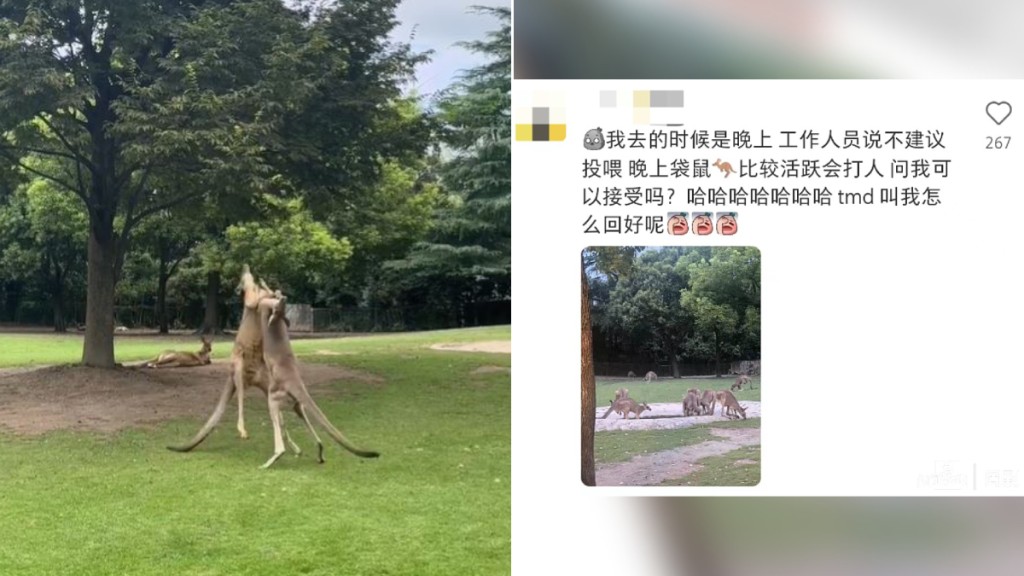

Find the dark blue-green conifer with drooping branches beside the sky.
[{"left": 386, "top": 6, "right": 512, "bottom": 315}]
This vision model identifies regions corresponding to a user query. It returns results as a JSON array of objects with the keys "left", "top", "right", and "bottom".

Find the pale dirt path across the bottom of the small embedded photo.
[{"left": 595, "top": 428, "right": 761, "bottom": 486}]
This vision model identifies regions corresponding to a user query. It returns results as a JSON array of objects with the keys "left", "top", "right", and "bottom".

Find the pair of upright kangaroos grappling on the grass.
[{"left": 168, "top": 265, "right": 380, "bottom": 468}]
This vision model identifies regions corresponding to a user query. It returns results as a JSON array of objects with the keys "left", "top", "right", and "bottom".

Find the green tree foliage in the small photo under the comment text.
[{"left": 584, "top": 247, "right": 761, "bottom": 364}]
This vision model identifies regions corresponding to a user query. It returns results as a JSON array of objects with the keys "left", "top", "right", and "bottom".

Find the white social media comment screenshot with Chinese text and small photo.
[{"left": 512, "top": 80, "right": 1024, "bottom": 496}]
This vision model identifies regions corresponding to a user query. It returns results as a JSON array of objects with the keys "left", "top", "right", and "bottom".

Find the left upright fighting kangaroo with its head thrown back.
[{"left": 167, "top": 264, "right": 276, "bottom": 452}]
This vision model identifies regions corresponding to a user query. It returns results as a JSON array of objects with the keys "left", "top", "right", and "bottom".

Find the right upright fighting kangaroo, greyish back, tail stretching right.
[{"left": 259, "top": 296, "right": 380, "bottom": 468}]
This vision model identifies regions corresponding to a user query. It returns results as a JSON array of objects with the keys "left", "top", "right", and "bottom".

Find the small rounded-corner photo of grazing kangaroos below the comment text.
[{"left": 582, "top": 246, "right": 757, "bottom": 486}]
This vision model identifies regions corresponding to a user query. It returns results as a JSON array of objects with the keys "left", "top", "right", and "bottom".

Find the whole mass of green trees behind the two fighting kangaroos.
[{"left": 0, "top": 0, "right": 511, "bottom": 367}]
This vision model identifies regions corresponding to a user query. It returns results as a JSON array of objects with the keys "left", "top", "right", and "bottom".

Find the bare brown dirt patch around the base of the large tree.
[{"left": 0, "top": 361, "right": 383, "bottom": 436}]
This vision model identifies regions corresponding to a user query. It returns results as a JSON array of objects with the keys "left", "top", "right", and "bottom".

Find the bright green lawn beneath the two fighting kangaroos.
[{"left": 0, "top": 327, "right": 511, "bottom": 576}]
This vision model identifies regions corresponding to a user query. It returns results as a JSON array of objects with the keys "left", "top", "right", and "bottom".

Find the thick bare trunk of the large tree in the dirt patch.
[{"left": 82, "top": 230, "right": 117, "bottom": 368}]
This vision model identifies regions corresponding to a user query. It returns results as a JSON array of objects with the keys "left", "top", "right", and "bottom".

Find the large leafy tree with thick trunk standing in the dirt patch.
[{"left": 0, "top": 0, "right": 426, "bottom": 367}]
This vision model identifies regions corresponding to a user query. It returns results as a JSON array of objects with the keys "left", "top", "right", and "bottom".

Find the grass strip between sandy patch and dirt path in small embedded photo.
[{"left": 594, "top": 418, "right": 761, "bottom": 464}]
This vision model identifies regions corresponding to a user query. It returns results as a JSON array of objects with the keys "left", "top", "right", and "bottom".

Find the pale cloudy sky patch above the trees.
[{"left": 393, "top": 0, "right": 511, "bottom": 96}]
